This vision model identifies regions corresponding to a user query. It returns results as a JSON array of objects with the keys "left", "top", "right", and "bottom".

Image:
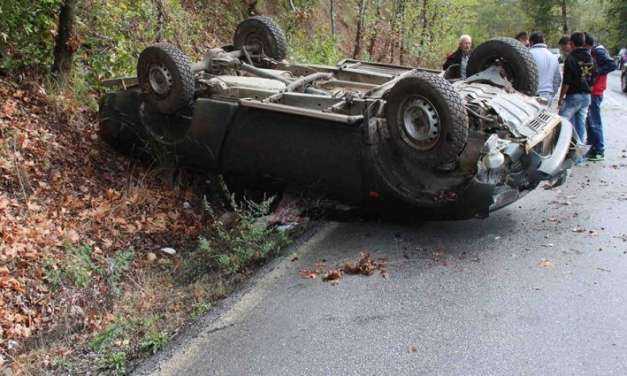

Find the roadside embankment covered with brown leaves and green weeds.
[{"left": 0, "top": 80, "right": 290, "bottom": 373}]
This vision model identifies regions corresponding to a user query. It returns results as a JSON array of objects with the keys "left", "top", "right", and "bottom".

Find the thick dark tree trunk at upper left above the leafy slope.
[{"left": 52, "top": 0, "right": 78, "bottom": 80}]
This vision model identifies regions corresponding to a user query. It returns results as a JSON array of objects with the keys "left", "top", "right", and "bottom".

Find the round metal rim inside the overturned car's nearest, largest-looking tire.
[{"left": 401, "top": 97, "right": 440, "bottom": 150}]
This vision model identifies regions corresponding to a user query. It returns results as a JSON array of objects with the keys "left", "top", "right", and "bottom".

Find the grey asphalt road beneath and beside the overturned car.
[{"left": 138, "top": 72, "right": 627, "bottom": 376}]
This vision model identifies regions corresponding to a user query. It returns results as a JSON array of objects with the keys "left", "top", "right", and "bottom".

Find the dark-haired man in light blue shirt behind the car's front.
[{"left": 529, "top": 31, "right": 562, "bottom": 106}]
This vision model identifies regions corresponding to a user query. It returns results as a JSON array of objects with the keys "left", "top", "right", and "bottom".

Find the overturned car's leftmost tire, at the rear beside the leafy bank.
[{"left": 137, "top": 43, "right": 195, "bottom": 114}]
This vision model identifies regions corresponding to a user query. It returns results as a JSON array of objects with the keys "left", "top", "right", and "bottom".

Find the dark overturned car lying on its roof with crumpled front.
[{"left": 100, "top": 16, "right": 582, "bottom": 218}]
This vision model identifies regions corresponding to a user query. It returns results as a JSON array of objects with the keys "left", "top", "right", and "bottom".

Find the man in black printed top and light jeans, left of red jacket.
[{"left": 558, "top": 32, "right": 594, "bottom": 141}]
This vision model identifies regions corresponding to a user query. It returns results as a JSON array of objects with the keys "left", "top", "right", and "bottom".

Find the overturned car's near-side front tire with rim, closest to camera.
[{"left": 385, "top": 71, "right": 468, "bottom": 167}]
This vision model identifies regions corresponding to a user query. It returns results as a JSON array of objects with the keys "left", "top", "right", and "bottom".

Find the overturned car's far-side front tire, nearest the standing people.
[{"left": 466, "top": 38, "right": 538, "bottom": 95}]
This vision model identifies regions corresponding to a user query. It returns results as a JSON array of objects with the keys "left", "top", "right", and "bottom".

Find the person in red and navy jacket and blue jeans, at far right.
[{"left": 584, "top": 33, "right": 616, "bottom": 162}]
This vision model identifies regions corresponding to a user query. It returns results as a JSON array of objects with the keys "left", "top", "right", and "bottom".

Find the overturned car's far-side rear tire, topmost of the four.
[{"left": 233, "top": 16, "right": 287, "bottom": 61}]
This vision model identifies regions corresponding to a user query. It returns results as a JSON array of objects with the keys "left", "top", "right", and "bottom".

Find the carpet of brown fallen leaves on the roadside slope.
[{"left": 0, "top": 82, "right": 204, "bottom": 352}]
